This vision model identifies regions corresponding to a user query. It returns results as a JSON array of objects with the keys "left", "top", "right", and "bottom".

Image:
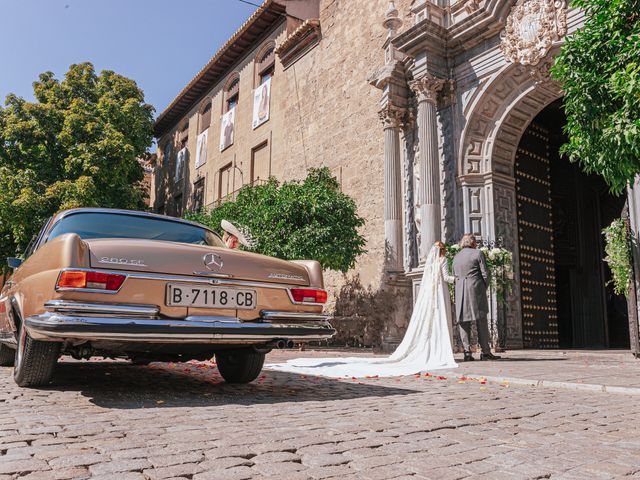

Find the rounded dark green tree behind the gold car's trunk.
[{"left": 186, "top": 168, "right": 365, "bottom": 272}]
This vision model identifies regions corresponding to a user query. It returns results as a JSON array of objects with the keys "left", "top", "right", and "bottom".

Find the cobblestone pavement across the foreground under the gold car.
[{"left": 0, "top": 352, "right": 640, "bottom": 480}]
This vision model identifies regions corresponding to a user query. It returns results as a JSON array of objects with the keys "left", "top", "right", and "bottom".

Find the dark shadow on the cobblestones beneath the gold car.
[{"left": 46, "top": 361, "right": 419, "bottom": 409}]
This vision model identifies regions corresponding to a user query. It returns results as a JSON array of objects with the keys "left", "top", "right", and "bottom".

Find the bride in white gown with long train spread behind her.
[{"left": 266, "top": 242, "right": 458, "bottom": 378}]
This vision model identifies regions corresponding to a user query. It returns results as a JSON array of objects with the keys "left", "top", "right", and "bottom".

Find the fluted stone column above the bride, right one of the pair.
[{"left": 409, "top": 75, "right": 444, "bottom": 263}]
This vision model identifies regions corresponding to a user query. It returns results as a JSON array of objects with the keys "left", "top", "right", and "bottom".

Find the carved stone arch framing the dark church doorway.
[{"left": 458, "top": 60, "right": 562, "bottom": 348}]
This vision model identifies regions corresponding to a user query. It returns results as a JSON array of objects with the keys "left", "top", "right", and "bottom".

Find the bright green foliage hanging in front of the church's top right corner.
[{"left": 552, "top": 0, "right": 640, "bottom": 194}]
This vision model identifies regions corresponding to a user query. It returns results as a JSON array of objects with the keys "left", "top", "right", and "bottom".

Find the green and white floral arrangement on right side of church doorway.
[{"left": 602, "top": 218, "right": 632, "bottom": 297}]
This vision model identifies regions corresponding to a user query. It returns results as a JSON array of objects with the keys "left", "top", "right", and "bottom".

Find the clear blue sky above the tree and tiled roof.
[{"left": 0, "top": 0, "right": 262, "bottom": 115}]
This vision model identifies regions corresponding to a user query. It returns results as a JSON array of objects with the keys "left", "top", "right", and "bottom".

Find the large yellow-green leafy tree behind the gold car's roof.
[{"left": 0, "top": 63, "right": 154, "bottom": 264}]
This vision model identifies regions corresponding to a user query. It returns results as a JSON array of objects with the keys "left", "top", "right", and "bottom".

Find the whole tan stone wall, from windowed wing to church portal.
[{"left": 153, "top": 0, "right": 420, "bottom": 348}]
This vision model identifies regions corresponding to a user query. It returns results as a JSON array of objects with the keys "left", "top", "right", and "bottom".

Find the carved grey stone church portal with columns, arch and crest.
[{"left": 372, "top": 0, "right": 583, "bottom": 347}]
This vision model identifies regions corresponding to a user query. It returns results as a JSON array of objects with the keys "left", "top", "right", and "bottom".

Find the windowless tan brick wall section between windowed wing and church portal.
[{"left": 280, "top": 0, "right": 411, "bottom": 346}]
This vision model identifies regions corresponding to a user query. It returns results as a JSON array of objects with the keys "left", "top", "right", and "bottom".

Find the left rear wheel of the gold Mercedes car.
[{"left": 13, "top": 322, "right": 60, "bottom": 387}]
